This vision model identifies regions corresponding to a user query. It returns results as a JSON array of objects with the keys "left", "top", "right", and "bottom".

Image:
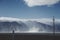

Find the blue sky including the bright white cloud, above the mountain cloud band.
[{"left": 0, "top": 0, "right": 60, "bottom": 18}]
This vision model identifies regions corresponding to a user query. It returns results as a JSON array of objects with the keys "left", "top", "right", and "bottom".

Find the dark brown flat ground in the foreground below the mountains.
[{"left": 0, "top": 33, "right": 60, "bottom": 40}]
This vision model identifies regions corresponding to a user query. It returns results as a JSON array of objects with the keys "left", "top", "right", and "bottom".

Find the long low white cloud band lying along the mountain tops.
[{"left": 0, "top": 17, "right": 60, "bottom": 24}]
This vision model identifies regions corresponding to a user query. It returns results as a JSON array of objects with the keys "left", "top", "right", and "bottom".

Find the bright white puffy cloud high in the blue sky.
[{"left": 24, "top": 0, "right": 60, "bottom": 7}]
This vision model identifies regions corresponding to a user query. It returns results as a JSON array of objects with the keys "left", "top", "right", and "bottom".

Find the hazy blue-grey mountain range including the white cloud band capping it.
[{"left": 0, "top": 17, "right": 60, "bottom": 33}]
